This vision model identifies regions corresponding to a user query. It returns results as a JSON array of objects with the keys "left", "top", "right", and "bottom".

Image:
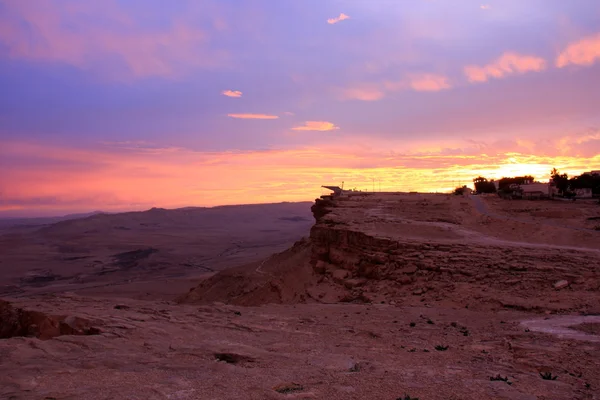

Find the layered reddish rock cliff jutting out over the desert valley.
[{"left": 182, "top": 194, "right": 600, "bottom": 311}]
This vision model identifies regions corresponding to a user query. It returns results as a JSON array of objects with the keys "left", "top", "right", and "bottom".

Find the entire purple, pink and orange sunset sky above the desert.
[{"left": 0, "top": 0, "right": 600, "bottom": 217}]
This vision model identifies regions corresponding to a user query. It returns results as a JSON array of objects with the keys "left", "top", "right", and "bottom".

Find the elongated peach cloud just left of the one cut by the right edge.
[{"left": 464, "top": 52, "right": 546, "bottom": 83}]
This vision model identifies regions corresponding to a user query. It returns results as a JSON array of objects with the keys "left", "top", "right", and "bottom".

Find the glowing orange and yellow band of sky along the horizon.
[{"left": 0, "top": 144, "right": 600, "bottom": 215}]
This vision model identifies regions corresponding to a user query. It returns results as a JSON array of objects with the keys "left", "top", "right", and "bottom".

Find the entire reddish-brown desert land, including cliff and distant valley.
[{"left": 0, "top": 193, "right": 600, "bottom": 400}]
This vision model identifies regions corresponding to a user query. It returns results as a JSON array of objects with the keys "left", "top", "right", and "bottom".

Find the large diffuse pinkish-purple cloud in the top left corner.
[{"left": 0, "top": 0, "right": 228, "bottom": 79}]
